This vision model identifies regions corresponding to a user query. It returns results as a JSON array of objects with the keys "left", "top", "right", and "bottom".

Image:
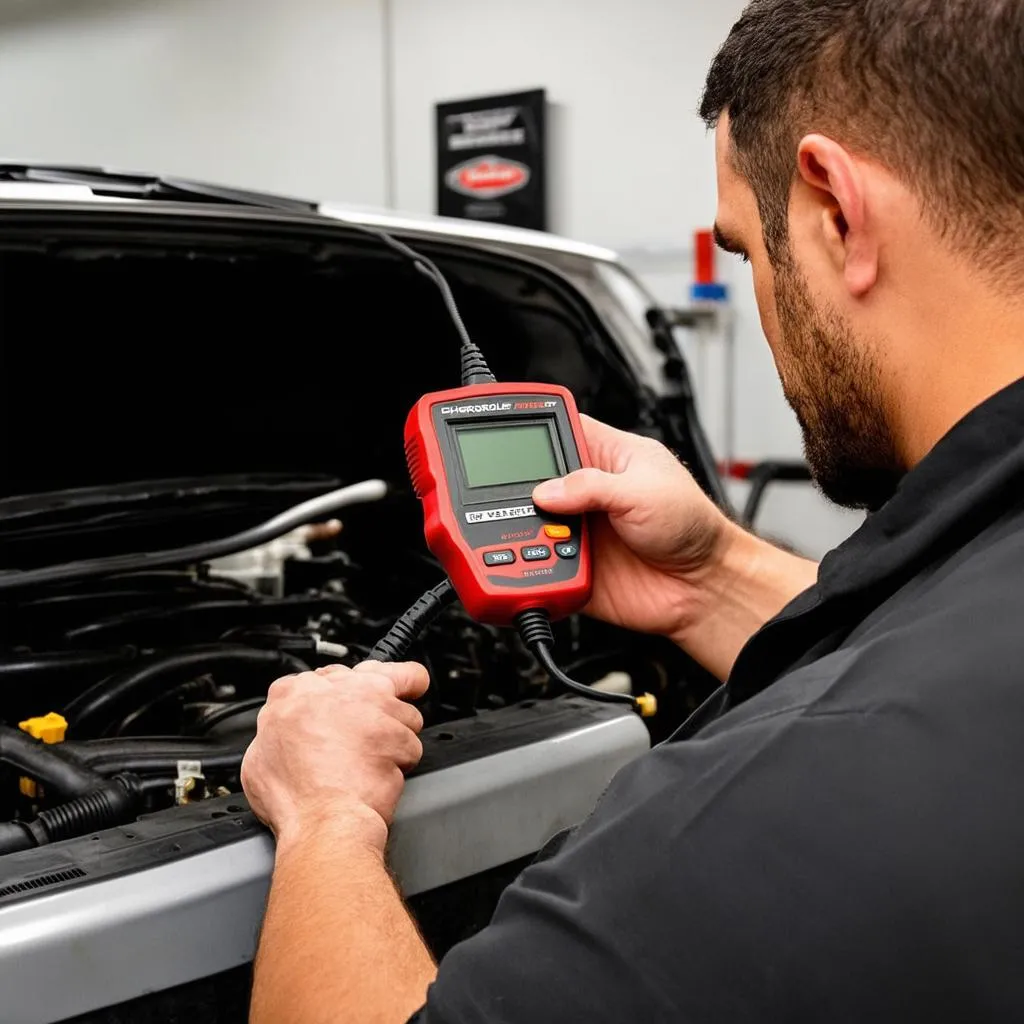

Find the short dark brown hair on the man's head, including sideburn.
[{"left": 700, "top": 0, "right": 1024, "bottom": 273}]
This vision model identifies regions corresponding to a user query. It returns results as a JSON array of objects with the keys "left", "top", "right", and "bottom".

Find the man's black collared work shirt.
[{"left": 414, "top": 381, "right": 1024, "bottom": 1024}]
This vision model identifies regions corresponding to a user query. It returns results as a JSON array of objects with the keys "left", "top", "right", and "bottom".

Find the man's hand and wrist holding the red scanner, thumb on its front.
[{"left": 534, "top": 416, "right": 817, "bottom": 679}]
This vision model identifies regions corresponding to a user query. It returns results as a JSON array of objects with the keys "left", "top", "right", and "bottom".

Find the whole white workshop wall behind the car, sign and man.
[{"left": 0, "top": 0, "right": 860, "bottom": 555}]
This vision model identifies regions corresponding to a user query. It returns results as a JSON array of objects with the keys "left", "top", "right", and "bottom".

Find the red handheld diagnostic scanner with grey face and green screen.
[{"left": 406, "top": 383, "right": 592, "bottom": 626}]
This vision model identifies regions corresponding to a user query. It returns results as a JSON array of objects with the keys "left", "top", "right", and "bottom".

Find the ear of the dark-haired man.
[{"left": 798, "top": 135, "right": 879, "bottom": 299}]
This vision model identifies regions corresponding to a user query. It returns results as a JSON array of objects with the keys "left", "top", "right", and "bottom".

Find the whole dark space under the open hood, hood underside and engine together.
[{"left": 0, "top": 211, "right": 712, "bottom": 854}]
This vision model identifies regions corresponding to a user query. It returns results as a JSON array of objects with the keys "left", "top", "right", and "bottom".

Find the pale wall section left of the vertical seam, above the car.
[{"left": 0, "top": 0, "right": 385, "bottom": 205}]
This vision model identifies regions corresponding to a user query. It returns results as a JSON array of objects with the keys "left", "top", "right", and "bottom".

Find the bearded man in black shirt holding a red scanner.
[{"left": 244, "top": 0, "right": 1024, "bottom": 1024}]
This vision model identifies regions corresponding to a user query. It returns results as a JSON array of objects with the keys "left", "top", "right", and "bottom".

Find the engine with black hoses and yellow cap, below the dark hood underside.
[{"left": 0, "top": 500, "right": 700, "bottom": 853}]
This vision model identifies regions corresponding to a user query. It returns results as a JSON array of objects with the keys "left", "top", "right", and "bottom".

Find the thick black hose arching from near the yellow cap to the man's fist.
[{"left": 63, "top": 645, "right": 307, "bottom": 737}]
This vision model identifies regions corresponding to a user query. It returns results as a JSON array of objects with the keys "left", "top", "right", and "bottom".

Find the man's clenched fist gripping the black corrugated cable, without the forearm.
[{"left": 242, "top": 662, "right": 429, "bottom": 852}]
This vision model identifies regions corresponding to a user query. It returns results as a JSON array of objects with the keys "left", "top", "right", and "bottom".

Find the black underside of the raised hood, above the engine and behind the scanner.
[{"left": 0, "top": 210, "right": 643, "bottom": 567}]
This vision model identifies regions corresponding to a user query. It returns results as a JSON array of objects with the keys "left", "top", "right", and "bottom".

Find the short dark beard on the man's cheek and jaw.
[{"left": 775, "top": 264, "right": 904, "bottom": 510}]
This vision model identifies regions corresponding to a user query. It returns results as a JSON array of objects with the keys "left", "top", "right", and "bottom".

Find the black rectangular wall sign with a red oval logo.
[{"left": 437, "top": 89, "right": 548, "bottom": 231}]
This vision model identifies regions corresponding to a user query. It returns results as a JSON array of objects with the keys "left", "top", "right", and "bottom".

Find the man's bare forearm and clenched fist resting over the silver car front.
[{"left": 242, "top": 663, "right": 436, "bottom": 1024}]
